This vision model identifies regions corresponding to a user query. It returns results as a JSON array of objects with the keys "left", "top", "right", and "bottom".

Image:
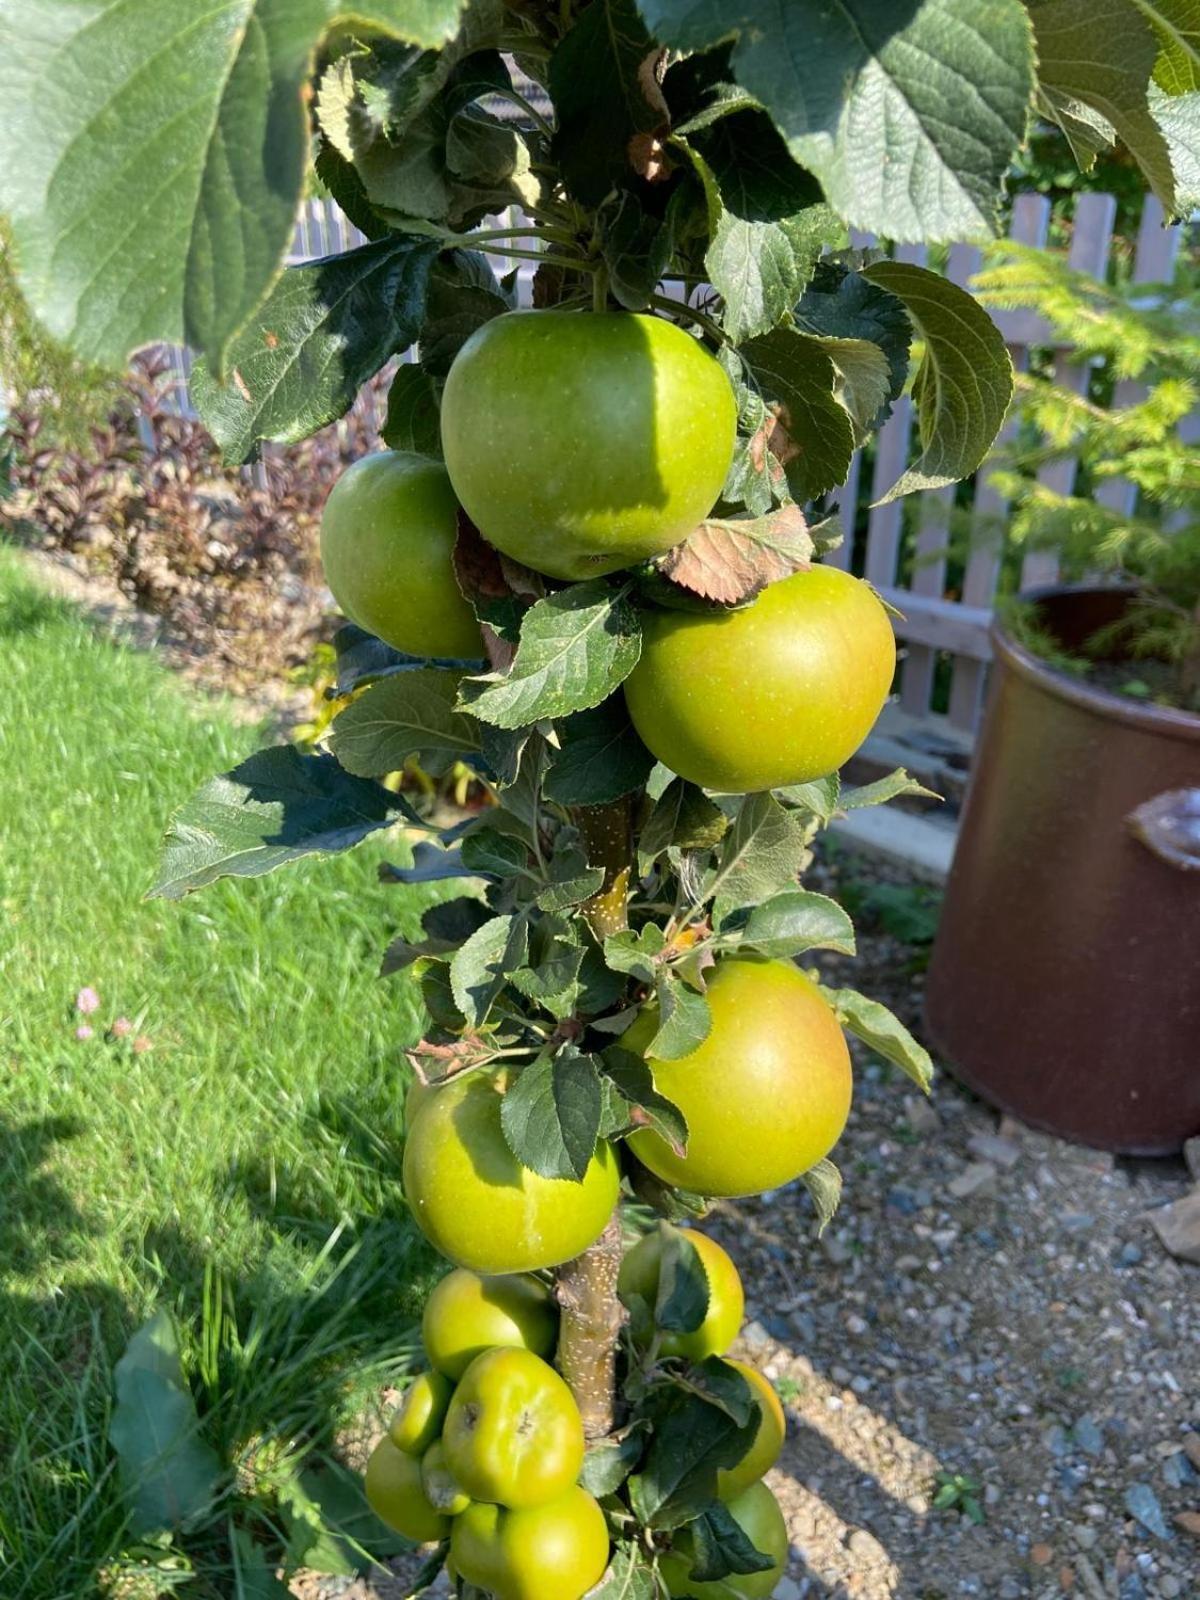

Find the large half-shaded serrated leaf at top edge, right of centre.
[{"left": 642, "top": 0, "right": 1034, "bottom": 240}]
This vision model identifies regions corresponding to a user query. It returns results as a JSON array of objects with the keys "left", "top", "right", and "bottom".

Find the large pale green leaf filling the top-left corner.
[{"left": 0, "top": 0, "right": 462, "bottom": 373}]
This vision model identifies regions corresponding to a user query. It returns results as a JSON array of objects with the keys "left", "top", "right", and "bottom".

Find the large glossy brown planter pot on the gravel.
[{"left": 926, "top": 587, "right": 1200, "bottom": 1155}]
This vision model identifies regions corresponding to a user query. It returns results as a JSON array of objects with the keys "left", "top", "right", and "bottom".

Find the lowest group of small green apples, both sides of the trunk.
[{"left": 365, "top": 1229, "right": 787, "bottom": 1600}]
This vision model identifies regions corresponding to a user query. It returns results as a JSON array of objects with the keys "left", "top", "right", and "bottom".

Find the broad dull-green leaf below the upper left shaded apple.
[{"left": 330, "top": 667, "right": 480, "bottom": 778}]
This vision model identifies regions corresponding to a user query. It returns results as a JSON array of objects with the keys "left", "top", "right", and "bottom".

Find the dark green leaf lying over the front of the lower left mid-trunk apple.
[{"left": 501, "top": 1046, "right": 602, "bottom": 1182}]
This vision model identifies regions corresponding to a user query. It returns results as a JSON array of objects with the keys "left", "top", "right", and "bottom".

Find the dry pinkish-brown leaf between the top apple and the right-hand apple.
[{"left": 658, "top": 506, "right": 813, "bottom": 605}]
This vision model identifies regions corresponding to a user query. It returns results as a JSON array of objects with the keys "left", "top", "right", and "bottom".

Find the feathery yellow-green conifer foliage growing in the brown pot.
[{"left": 976, "top": 245, "right": 1200, "bottom": 710}]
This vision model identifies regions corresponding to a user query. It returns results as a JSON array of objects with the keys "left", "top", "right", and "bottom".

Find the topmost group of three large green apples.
[{"left": 322, "top": 310, "right": 896, "bottom": 794}]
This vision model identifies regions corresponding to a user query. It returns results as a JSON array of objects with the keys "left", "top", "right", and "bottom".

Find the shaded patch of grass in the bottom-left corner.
[{"left": 0, "top": 1118, "right": 440, "bottom": 1600}]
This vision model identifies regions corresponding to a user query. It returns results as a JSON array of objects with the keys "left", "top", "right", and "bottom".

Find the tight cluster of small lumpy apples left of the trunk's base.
[{"left": 365, "top": 1267, "right": 610, "bottom": 1600}]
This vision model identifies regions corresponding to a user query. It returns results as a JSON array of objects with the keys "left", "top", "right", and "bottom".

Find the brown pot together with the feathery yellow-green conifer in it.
[{"left": 926, "top": 245, "right": 1200, "bottom": 1154}]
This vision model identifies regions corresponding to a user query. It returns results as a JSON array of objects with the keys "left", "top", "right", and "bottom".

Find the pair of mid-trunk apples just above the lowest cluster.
[{"left": 403, "top": 955, "right": 853, "bottom": 1272}]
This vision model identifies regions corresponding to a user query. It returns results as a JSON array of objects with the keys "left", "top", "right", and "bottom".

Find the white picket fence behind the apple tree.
[{"left": 171, "top": 194, "right": 1200, "bottom": 736}]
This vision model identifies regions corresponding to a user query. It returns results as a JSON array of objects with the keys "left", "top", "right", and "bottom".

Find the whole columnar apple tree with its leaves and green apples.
[{"left": 0, "top": 0, "right": 1198, "bottom": 1600}]
